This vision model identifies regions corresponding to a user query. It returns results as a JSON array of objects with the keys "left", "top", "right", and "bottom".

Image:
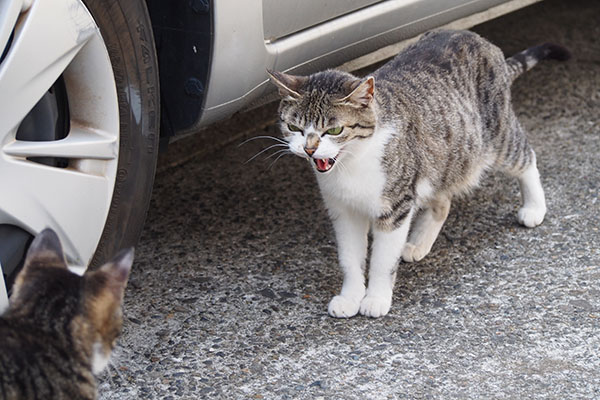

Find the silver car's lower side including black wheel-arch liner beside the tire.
[{"left": 147, "top": 0, "right": 538, "bottom": 135}]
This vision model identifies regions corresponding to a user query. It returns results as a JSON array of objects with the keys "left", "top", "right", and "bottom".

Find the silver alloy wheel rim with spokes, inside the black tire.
[{"left": 0, "top": 0, "right": 119, "bottom": 282}]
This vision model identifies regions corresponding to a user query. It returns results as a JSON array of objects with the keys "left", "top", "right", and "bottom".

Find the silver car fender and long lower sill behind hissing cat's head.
[{"left": 197, "top": 0, "right": 520, "bottom": 130}]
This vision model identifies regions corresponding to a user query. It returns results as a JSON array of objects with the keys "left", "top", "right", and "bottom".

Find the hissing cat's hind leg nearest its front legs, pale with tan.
[{"left": 402, "top": 196, "right": 450, "bottom": 262}]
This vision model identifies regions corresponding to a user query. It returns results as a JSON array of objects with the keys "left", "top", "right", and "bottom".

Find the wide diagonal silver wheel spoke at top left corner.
[{"left": 0, "top": 0, "right": 97, "bottom": 141}]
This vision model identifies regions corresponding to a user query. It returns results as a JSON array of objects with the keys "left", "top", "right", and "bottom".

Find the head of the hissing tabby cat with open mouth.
[{"left": 268, "top": 70, "right": 376, "bottom": 173}]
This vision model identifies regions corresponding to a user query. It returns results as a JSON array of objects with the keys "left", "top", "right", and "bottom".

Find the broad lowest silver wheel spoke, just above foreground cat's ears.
[{"left": 0, "top": 159, "right": 112, "bottom": 265}]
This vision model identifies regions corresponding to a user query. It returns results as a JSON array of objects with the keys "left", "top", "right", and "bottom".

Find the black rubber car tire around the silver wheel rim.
[{"left": 84, "top": 0, "right": 160, "bottom": 267}]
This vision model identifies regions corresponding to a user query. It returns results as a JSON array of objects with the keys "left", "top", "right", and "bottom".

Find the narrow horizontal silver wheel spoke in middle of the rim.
[{"left": 3, "top": 126, "right": 118, "bottom": 160}]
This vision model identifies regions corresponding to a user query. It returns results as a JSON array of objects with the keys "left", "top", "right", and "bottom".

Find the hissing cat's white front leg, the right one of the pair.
[{"left": 360, "top": 210, "right": 413, "bottom": 318}]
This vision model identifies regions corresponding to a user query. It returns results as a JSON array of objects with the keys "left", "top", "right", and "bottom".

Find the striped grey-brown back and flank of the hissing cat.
[{"left": 374, "top": 30, "right": 510, "bottom": 198}]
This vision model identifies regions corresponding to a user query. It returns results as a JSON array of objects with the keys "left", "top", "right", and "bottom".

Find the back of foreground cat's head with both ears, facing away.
[{"left": 6, "top": 229, "right": 133, "bottom": 374}]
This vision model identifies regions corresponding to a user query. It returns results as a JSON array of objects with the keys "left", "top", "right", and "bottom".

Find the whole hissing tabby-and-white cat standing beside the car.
[{"left": 269, "top": 31, "right": 569, "bottom": 318}]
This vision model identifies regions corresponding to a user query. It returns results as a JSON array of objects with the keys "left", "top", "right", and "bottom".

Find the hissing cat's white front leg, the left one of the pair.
[{"left": 328, "top": 210, "right": 369, "bottom": 318}]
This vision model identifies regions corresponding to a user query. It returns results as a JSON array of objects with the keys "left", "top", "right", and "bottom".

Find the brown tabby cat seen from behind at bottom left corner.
[{"left": 0, "top": 229, "right": 133, "bottom": 400}]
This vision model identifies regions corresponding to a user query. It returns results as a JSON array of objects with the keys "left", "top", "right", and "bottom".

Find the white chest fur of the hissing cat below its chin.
[{"left": 317, "top": 129, "right": 392, "bottom": 219}]
